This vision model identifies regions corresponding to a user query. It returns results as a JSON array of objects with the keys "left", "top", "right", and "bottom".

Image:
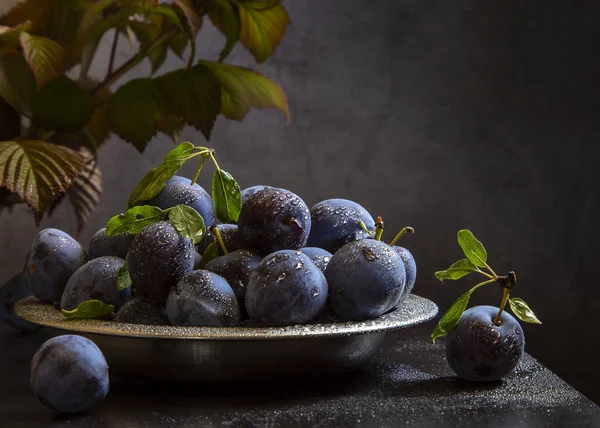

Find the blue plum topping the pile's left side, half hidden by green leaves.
[{"left": 143, "top": 176, "right": 215, "bottom": 227}]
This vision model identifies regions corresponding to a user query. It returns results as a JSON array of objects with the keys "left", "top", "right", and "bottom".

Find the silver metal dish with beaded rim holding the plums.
[{"left": 14, "top": 295, "right": 438, "bottom": 382}]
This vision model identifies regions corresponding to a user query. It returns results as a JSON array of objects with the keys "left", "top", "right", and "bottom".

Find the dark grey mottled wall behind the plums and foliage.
[{"left": 0, "top": 0, "right": 600, "bottom": 402}]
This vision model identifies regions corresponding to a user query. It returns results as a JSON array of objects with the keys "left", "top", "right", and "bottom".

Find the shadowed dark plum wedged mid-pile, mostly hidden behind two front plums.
[{"left": 205, "top": 250, "right": 262, "bottom": 315}]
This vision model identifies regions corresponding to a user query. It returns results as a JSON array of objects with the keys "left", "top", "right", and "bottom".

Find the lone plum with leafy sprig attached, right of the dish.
[{"left": 431, "top": 229, "right": 541, "bottom": 382}]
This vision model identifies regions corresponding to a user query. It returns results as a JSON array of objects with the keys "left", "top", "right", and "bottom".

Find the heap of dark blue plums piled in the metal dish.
[{"left": 23, "top": 176, "right": 416, "bottom": 327}]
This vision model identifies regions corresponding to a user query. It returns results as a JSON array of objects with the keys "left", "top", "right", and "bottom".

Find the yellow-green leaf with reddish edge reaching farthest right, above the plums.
[{"left": 199, "top": 61, "right": 290, "bottom": 121}]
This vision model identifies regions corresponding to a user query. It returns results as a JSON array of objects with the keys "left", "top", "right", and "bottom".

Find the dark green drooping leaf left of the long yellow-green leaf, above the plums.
[{"left": 108, "top": 78, "right": 178, "bottom": 153}]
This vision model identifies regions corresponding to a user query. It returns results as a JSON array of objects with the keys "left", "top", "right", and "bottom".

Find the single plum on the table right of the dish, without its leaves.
[{"left": 446, "top": 306, "right": 525, "bottom": 382}]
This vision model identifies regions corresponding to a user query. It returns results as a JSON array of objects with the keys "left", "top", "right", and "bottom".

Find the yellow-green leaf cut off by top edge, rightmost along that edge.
[{"left": 236, "top": 1, "right": 290, "bottom": 64}]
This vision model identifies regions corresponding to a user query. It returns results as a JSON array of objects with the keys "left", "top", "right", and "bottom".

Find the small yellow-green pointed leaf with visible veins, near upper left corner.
[{"left": 19, "top": 31, "right": 66, "bottom": 89}]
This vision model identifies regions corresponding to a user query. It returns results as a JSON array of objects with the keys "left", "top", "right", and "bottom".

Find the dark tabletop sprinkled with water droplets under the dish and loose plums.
[{"left": 0, "top": 325, "right": 600, "bottom": 428}]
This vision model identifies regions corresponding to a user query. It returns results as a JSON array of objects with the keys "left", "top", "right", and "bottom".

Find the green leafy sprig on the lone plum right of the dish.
[{"left": 431, "top": 229, "right": 541, "bottom": 342}]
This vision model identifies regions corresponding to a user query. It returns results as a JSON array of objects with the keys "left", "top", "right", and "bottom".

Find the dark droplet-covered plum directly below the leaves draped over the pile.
[{"left": 127, "top": 221, "right": 196, "bottom": 303}]
